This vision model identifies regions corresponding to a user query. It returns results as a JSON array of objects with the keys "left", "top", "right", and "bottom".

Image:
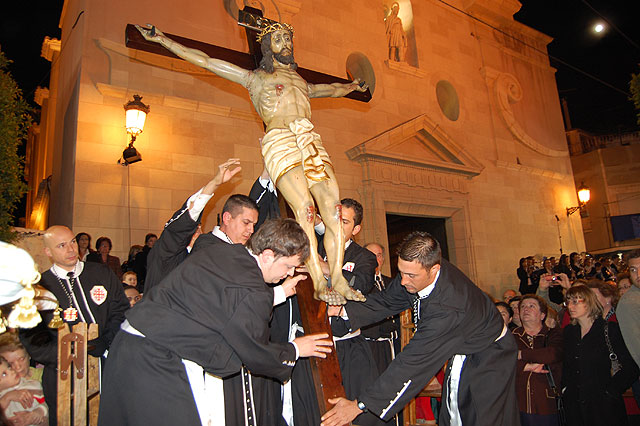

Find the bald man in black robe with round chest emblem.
[{"left": 20, "top": 226, "right": 129, "bottom": 424}]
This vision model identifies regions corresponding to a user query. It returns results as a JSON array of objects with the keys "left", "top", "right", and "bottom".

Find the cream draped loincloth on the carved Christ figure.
[{"left": 261, "top": 118, "right": 333, "bottom": 186}]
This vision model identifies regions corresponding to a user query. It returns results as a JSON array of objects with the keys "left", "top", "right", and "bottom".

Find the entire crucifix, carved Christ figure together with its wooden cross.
[{"left": 126, "top": 9, "right": 371, "bottom": 412}]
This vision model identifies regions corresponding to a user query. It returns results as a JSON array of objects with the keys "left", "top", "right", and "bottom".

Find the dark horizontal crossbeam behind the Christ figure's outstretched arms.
[{"left": 125, "top": 15, "right": 371, "bottom": 102}]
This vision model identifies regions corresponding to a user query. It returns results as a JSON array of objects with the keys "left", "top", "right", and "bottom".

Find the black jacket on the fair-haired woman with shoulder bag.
[{"left": 562, "top": 318, "right": 639, "bottom": 426}]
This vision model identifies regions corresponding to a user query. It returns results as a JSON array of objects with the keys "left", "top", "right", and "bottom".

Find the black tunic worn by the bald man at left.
[{"left": 20, "top": 262, "right": 129, "bottom": 424}]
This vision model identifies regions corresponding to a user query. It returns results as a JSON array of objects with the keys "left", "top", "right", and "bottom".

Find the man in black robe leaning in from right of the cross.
[{"left": 322, "top": 232, "right": 520, "bottom": 426}]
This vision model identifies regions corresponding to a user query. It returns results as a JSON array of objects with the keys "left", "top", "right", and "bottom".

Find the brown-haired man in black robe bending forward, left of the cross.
[{"left": 99, "top": 219, "right": 331, "bottom": 425}]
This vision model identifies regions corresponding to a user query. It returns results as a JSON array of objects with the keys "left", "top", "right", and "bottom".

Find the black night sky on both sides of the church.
[{"left": 0, "top": 0, "right": 640, "bottom": 133}]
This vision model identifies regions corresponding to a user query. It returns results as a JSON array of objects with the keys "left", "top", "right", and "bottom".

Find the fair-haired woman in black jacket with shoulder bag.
[{"left": 562, "top": 284, "right": 640, "bottom": 426}]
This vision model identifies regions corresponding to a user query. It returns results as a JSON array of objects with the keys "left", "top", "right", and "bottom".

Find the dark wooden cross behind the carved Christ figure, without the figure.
[{"left": 126, "top": 7, "right": 360, "bottom": 413}]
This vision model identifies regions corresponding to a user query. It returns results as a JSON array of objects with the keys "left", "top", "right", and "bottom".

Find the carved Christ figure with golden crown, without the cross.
[{"left": 136, "top": 23, "right": 367, "bottom": 304}]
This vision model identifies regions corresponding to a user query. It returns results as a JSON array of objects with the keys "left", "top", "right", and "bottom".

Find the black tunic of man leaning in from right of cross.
[{"left": 346, "top": 259, "right": 520, "bottom": 426}]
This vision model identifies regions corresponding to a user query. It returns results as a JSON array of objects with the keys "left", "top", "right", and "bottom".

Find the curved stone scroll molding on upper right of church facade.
[{"left": 482, "top": 67, "right": 569, "bottom": 157}]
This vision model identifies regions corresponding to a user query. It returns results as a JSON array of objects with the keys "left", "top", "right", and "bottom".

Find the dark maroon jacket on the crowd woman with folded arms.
[{"left": 513, "top": 324, "right": 562, "bottom": 415}]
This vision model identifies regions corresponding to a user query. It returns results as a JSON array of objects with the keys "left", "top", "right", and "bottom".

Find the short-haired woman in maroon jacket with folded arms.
[{"left": 513, "top": 294, "right": 562, "bottom": 426}]
